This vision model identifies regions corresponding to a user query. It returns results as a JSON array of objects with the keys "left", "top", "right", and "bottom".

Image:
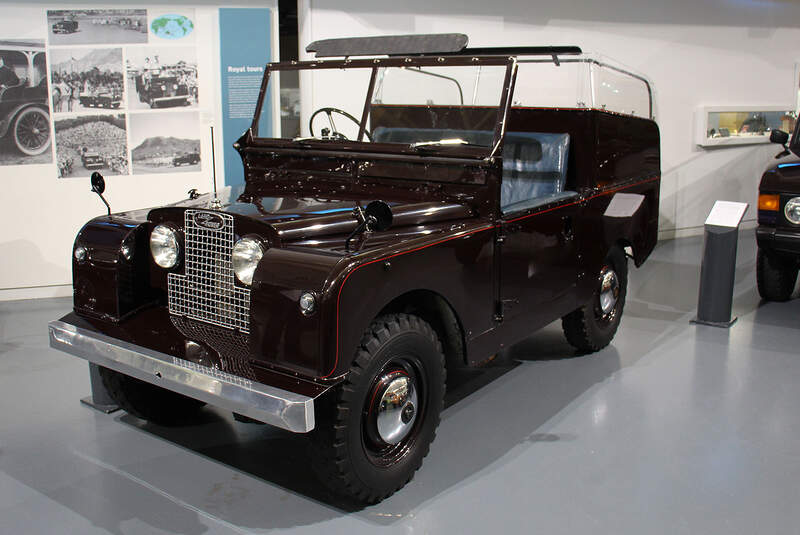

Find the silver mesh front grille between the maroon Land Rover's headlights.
[{"left": 167, "top": 210, "right": 250, "bottom": 332}]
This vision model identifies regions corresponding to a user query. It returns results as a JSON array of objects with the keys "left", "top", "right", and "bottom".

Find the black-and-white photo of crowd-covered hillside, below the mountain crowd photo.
[{"left": 55, "top": 114, "right": 130, "bottom": 178}]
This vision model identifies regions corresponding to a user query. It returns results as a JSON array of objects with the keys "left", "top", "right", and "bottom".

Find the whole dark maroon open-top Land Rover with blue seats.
[{"left": 50, "top": 34, "right": 660, "bottom": 503}]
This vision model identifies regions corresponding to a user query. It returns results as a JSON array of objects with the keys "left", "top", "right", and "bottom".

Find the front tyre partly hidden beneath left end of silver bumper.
[{"left": 100, "top": 367, "right": 205, "bottom": 426}]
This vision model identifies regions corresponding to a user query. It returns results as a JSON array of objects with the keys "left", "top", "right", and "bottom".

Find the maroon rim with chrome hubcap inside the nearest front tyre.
[{"left": 362, "top": 357, "right": 425, "bottom": 466}]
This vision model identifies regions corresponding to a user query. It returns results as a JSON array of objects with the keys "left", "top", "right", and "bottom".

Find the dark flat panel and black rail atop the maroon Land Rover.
[{"left": 306, "top": 33, "right": 582, "bottom": 58}]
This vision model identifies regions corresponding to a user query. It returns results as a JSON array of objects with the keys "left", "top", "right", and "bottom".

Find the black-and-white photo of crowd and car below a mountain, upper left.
[{"left": 50, "top": 48, "right": 125, "bottom": 113}]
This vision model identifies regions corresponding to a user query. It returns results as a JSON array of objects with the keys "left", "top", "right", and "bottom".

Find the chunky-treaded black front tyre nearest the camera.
[{"left": 312, "top": 314, "right": 445, "bottom": 504}]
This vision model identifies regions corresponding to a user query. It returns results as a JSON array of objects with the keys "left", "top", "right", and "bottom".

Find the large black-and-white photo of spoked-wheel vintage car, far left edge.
[{"left": 0, "top": 39, "right": 53, "bottom": 165}]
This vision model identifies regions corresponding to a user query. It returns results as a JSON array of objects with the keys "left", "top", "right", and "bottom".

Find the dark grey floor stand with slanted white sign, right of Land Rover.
[{"left": 691, "top": 201, "right": 747, "bottom": 327}]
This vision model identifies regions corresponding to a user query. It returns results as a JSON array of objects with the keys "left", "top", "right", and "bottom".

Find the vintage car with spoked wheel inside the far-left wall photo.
[{"left": 0, "top": 41, "right": 51, "bottom": 156}]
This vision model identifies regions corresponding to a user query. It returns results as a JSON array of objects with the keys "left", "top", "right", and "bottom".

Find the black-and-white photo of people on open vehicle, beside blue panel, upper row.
[{"left": 126, "top": 47, "right": 198, "bottom": 110}]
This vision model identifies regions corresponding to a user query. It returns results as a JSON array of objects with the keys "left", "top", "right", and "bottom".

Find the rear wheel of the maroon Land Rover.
[{"left": 561, "top": 246, "right": 628, "bottom": 353}]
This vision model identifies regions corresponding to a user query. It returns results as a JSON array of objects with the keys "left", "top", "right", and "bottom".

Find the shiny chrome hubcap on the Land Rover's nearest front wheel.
[{"left": 376, "top": 372, "right": 417, "bottom": 445}]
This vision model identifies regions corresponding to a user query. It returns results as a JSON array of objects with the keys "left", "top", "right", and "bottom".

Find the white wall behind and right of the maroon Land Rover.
[{"left": 300, "top": 0, "right": 800, "bottom": 239}]
